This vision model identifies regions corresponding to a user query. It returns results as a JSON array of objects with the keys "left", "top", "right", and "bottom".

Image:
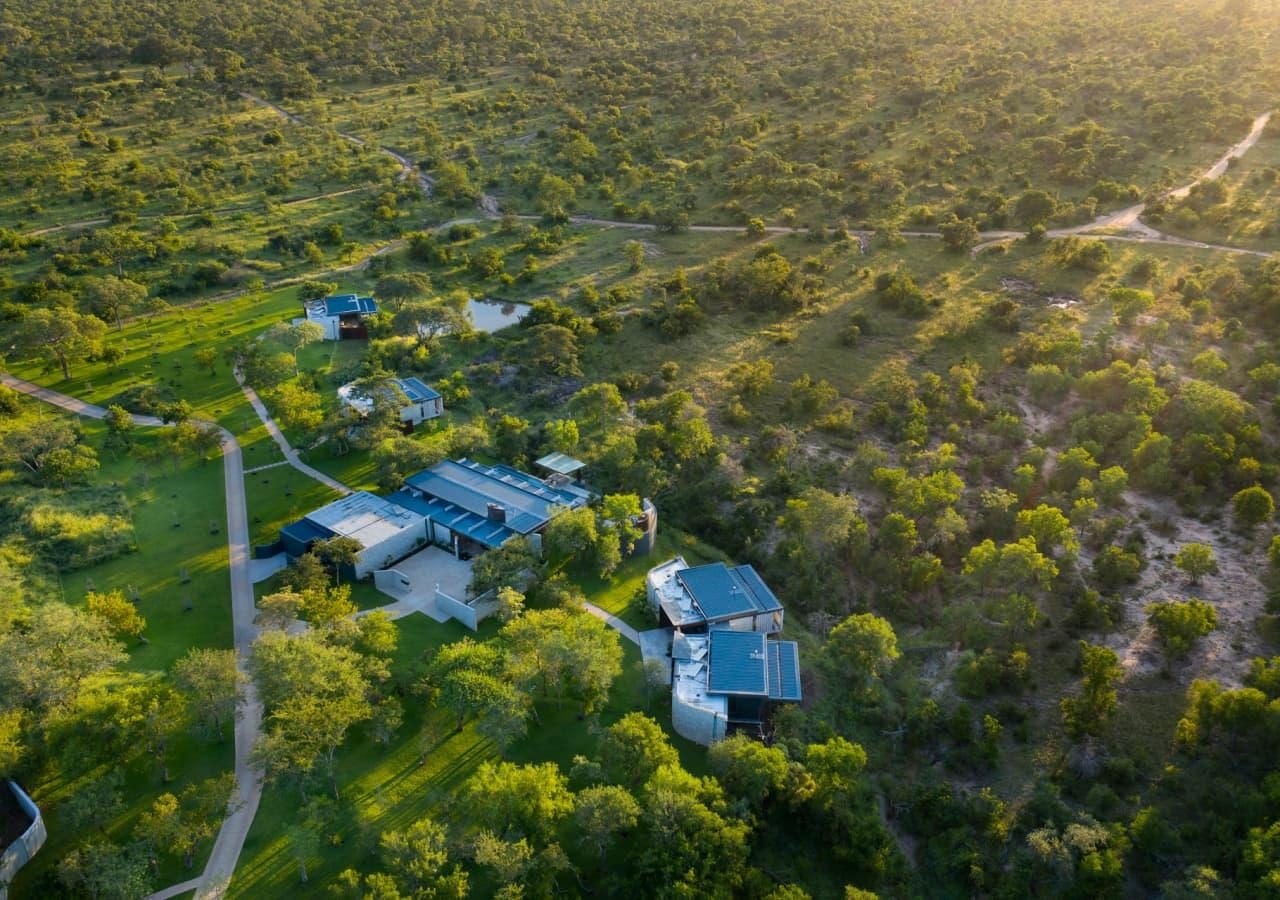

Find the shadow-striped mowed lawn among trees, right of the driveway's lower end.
[{"left": 230, "top": 613, "right": 705, "bottom": 897}]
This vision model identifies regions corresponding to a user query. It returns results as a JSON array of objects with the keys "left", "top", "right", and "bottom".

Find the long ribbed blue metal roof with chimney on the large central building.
[{"left": 404, "top": 460, "right": 585, "bottom": 534}]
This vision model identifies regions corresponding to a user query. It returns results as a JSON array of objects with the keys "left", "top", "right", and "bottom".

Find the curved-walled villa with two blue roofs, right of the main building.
[{"left": 645, "top": 557, "right": 801, "bottom": 744}]
